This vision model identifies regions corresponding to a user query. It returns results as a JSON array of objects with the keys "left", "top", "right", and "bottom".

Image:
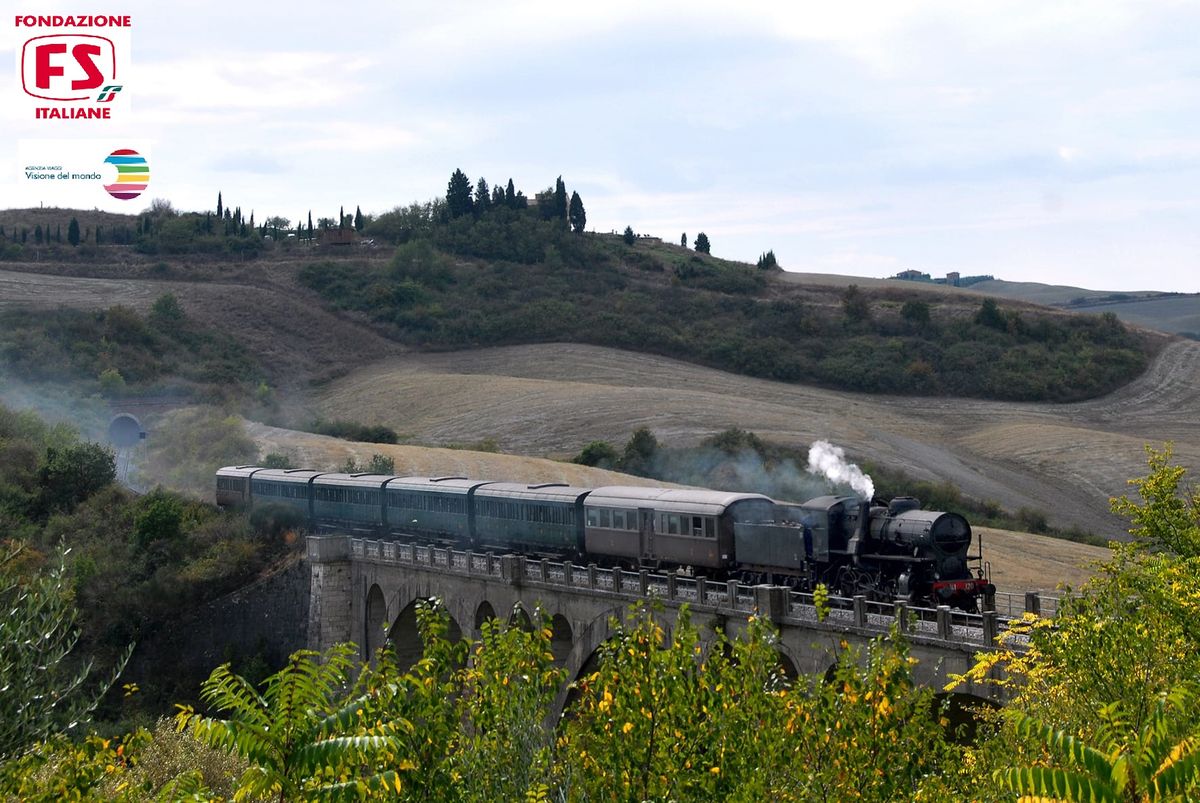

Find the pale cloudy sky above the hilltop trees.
[{"left": 0, "top": 0, "right": 1200, "bottom": 292}]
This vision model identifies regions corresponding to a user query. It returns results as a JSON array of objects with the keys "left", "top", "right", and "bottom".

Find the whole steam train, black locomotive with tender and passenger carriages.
[{"left": 216, "top": 466, "right": 995, "bottom": 611}]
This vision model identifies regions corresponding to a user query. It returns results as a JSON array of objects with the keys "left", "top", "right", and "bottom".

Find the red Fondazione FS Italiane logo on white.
[{"left": 14, "top": 14, "right": 132, "bottom": 120}]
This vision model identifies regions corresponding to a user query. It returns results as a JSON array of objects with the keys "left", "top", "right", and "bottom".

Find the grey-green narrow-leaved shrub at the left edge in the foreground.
[{"left": 0, "top": 544, "right": 130, "bottom": 759}]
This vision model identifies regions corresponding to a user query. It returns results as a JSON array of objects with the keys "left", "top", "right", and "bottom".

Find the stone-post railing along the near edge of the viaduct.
[{"left": 350, "top": 538, "right": 1058, "bottom": 647}]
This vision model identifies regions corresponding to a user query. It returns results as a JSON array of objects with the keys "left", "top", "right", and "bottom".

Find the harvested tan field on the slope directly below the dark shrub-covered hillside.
[{"left": 314, "top": 341, "right": 1200, "bottom": 537}]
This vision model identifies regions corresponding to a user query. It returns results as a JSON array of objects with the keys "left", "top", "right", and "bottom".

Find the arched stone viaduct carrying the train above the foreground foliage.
[{"left": 307, "top": 535, "right": 1051, "bottom": 709}]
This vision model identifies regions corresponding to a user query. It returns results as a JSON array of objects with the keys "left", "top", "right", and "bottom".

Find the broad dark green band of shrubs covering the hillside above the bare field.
[{"left": 300, "top": 222, "right": 1150, "bottom": 401}]
